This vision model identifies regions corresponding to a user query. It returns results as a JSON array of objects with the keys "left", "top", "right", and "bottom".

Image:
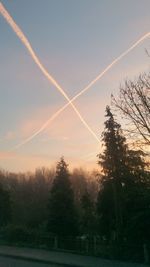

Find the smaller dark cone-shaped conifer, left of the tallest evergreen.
[{"left": 48, "top": 157, "right": 78, "bottom": 236}]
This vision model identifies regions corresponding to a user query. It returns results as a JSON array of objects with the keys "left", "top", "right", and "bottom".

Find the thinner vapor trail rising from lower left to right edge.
[{"left": 12, "top": 32, "right": 150, "bottom": 149}]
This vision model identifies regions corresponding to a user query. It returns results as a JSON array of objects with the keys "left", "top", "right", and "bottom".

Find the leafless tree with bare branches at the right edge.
[{"left": 112, "top": 73, "right": 150, "bottom": 145}]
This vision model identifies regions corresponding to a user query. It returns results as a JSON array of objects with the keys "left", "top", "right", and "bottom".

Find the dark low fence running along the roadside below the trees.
[{"left": 0, "top": 230, "right": 150, "bottom": 263}]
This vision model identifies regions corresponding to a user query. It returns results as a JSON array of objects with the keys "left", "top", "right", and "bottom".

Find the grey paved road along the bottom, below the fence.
[{"left": 0, "top": 246, "right": 145, "bottom": 267}]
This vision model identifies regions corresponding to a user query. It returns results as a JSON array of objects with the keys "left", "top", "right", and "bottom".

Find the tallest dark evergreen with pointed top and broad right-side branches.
[{"left": 97, "top": 107, "right": 145, "bottom": 241}]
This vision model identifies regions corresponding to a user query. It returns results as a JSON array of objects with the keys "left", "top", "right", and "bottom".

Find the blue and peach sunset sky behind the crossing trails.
[{"left": 0, "top": 0, "right": 150, "bottom": 172}]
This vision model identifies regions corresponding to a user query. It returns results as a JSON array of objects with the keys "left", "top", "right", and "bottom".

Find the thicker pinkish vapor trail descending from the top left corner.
[{"left": 0, "top": 2, "right": 100, "bottom": 143}]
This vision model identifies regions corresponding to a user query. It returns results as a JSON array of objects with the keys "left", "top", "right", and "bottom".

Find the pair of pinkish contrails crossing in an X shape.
[{"left": 0, "top": 2, "right": 150, "bottom": 150}]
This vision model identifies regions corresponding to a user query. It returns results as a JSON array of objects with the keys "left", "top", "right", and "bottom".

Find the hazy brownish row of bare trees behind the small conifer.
[{"left": 0, "top": 167, "right": 98, "bottom": 234}]
